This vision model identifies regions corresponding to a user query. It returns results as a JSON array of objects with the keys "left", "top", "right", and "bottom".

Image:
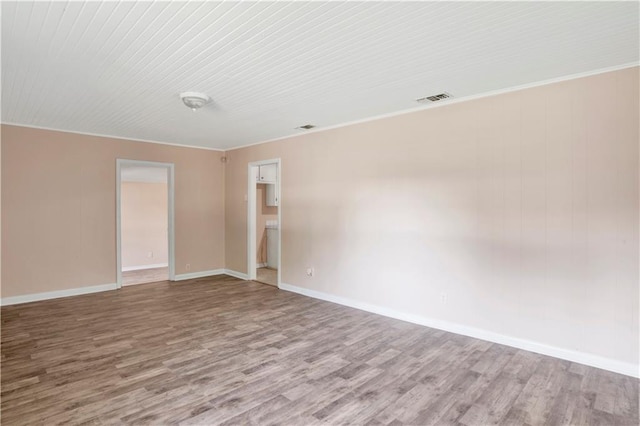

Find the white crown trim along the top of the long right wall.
[{"left": 225, "top": 62, "right": 640, "bottom": 152}]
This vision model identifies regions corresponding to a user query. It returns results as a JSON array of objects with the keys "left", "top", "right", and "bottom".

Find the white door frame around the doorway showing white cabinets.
[{"left": 247, "top": 158, "right": 282, "bottom": 288}]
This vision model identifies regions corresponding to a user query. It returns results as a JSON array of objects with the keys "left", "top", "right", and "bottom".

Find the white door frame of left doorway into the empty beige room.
[{"left": 116, "top": 158, "right": 176, "bottom": 288}]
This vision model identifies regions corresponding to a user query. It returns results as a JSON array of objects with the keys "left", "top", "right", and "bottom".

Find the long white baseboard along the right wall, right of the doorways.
[{"left": 278, "top": 283, "right": 640, "bottom": 377}]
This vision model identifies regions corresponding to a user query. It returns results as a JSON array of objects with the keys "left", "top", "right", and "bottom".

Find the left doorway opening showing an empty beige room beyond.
[{"left": 116, "top": 159, "right": 175, "bottom": 288}]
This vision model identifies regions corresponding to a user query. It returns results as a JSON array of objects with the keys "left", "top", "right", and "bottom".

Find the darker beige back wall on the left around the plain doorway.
[{"left": 2, "top": 125, "right": 224, "bottom": 297}]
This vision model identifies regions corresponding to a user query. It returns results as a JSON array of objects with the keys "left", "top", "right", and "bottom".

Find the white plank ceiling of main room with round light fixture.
[{"left": 2, "top": 1, "right": 639, "bottom": 149}]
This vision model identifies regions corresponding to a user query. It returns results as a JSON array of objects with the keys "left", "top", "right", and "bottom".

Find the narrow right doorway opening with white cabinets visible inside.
[{"left": 247, "top": 159, "right": 282, "bottom": 287}]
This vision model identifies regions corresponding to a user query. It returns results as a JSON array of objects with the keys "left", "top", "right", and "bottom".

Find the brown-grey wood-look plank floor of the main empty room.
[{"left": 1, "top": 276, "right": 639, "bottom": 426}]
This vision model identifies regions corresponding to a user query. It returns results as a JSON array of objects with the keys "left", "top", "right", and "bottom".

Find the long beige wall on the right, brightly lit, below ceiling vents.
[{"left": 225, "top": 68, "right": 639, "bottom": 364}]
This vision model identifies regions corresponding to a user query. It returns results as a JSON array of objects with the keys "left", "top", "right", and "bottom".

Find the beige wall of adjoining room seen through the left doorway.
[{"left": 120, "top": 182, "right": 169, "bottom": 268}]
